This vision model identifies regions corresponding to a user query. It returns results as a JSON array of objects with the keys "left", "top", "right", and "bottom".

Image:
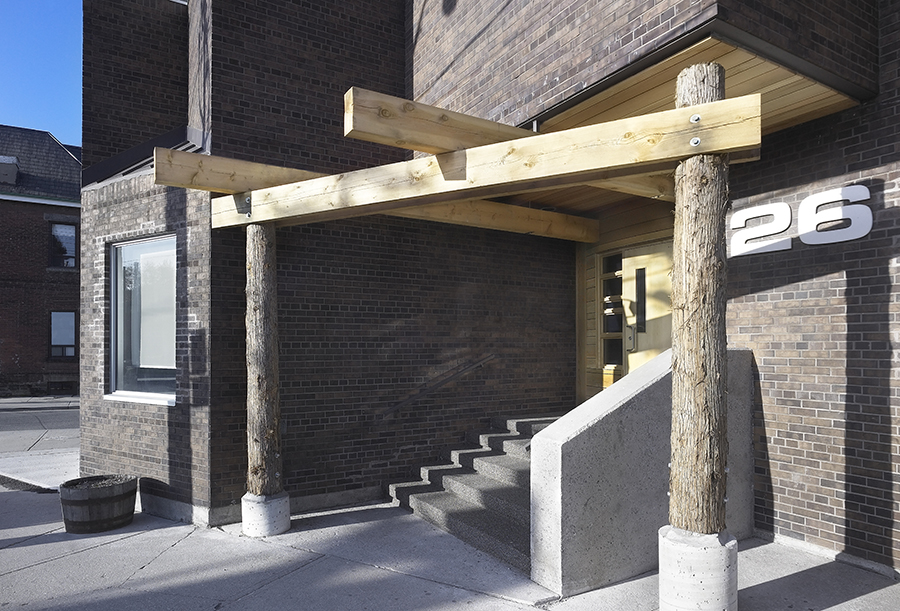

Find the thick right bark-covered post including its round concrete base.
[{"left": 659, "top": 64, "right": 737, "bottom": 611}]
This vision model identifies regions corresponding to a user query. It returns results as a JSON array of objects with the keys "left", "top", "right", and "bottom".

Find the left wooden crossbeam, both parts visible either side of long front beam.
[{"left": 153, "top": 149, "right": 600, "bottom": 242}]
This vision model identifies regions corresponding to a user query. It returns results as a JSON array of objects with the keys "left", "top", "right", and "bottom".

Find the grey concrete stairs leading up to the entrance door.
[{"left": 389, "top": 416, "right": 557, "bottom": 574}]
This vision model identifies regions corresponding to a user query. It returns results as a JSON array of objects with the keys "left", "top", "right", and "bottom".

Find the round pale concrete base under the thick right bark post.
[{"left": 659, "top": 526, "right": 738, "bottom": 611}]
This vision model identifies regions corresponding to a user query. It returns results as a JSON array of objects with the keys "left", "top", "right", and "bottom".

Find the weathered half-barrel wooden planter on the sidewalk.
[{"left": 59, "top": 475, "right": 137, "bottom": 534}]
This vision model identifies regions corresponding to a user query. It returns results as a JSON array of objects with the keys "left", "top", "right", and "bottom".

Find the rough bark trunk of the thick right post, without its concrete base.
[{"left": 669, "top": 64, "right": 729, "bottom": 534}]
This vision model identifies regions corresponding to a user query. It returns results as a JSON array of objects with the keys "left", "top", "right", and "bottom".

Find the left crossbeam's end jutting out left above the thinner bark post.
[{"left": 153, "top": 148, "right": 325, "bottom": 193}]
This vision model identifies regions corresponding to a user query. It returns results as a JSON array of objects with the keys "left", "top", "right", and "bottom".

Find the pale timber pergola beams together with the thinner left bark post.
[{"left": 154, "top": 80, "right": 761, "bottom": 536}]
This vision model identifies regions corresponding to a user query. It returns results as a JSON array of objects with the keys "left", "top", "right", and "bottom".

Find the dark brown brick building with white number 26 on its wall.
[{"left": 81, "top": 0, "right": 900, "bottom": 584}]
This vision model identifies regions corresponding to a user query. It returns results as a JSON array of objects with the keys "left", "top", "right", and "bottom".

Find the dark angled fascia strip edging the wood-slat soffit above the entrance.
[{"left": 518, "top": 17, "right": 878, "bottom": 129}]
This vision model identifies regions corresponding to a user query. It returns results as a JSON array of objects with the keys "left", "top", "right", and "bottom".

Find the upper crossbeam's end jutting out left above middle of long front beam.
[{"left": 344, "top": 87, "right": 535, "bottom": 154}]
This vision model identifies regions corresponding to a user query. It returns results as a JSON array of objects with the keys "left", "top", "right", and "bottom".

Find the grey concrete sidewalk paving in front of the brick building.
[{"left": 0, "top": 399, "right": 900, "bottom": 611}]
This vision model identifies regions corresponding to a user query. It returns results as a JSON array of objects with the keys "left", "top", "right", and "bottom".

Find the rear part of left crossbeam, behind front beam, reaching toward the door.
[{"left": 391, "top": 200, "right": 600, "bottom": 244}]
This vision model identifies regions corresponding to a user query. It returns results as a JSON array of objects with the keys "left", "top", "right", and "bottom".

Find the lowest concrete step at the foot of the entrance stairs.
[{"left": 410, "top": 492, "right": 531, "bottom": 574}]
